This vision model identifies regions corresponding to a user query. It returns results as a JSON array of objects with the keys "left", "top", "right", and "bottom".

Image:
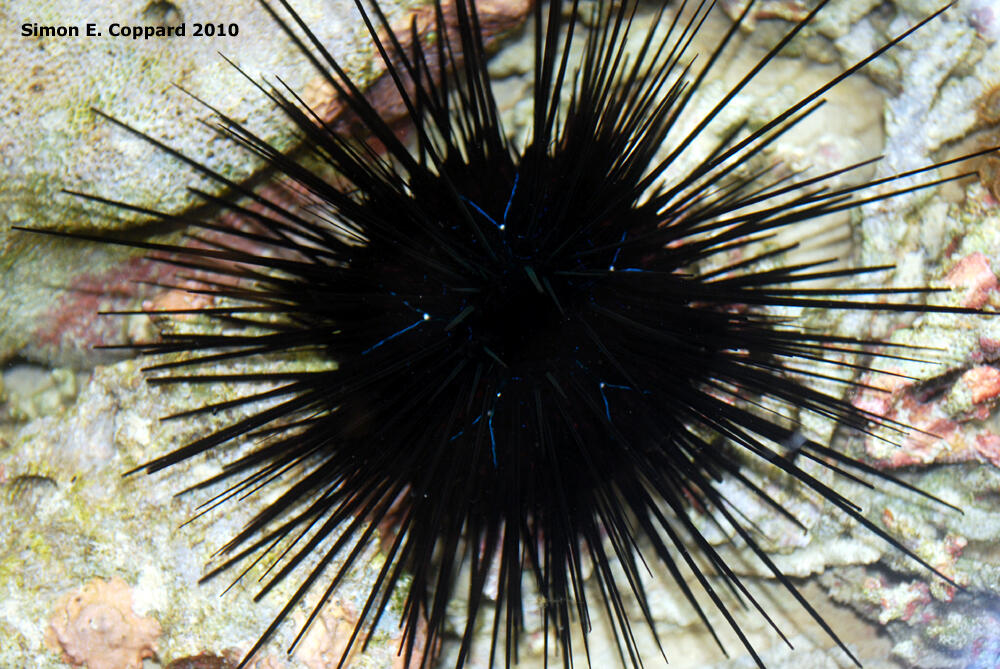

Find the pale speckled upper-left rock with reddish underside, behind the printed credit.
[{"left": 0, "top": 0, "right": 528, "bottom": 368}]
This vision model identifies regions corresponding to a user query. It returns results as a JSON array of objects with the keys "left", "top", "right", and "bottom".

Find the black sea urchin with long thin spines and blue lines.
[{"left": 19, "top": 0, "right": 996, "bottom": 667}]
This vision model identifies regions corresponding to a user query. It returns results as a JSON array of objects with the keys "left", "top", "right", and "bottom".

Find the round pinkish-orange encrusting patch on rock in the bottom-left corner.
[{"left": 45, "top": 577, "right": 160, "bottom": 669}]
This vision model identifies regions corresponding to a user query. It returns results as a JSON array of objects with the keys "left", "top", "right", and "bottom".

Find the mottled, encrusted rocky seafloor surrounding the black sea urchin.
[{"left": 0, "top": 0, "right": 1000, "bottom": 669}]
